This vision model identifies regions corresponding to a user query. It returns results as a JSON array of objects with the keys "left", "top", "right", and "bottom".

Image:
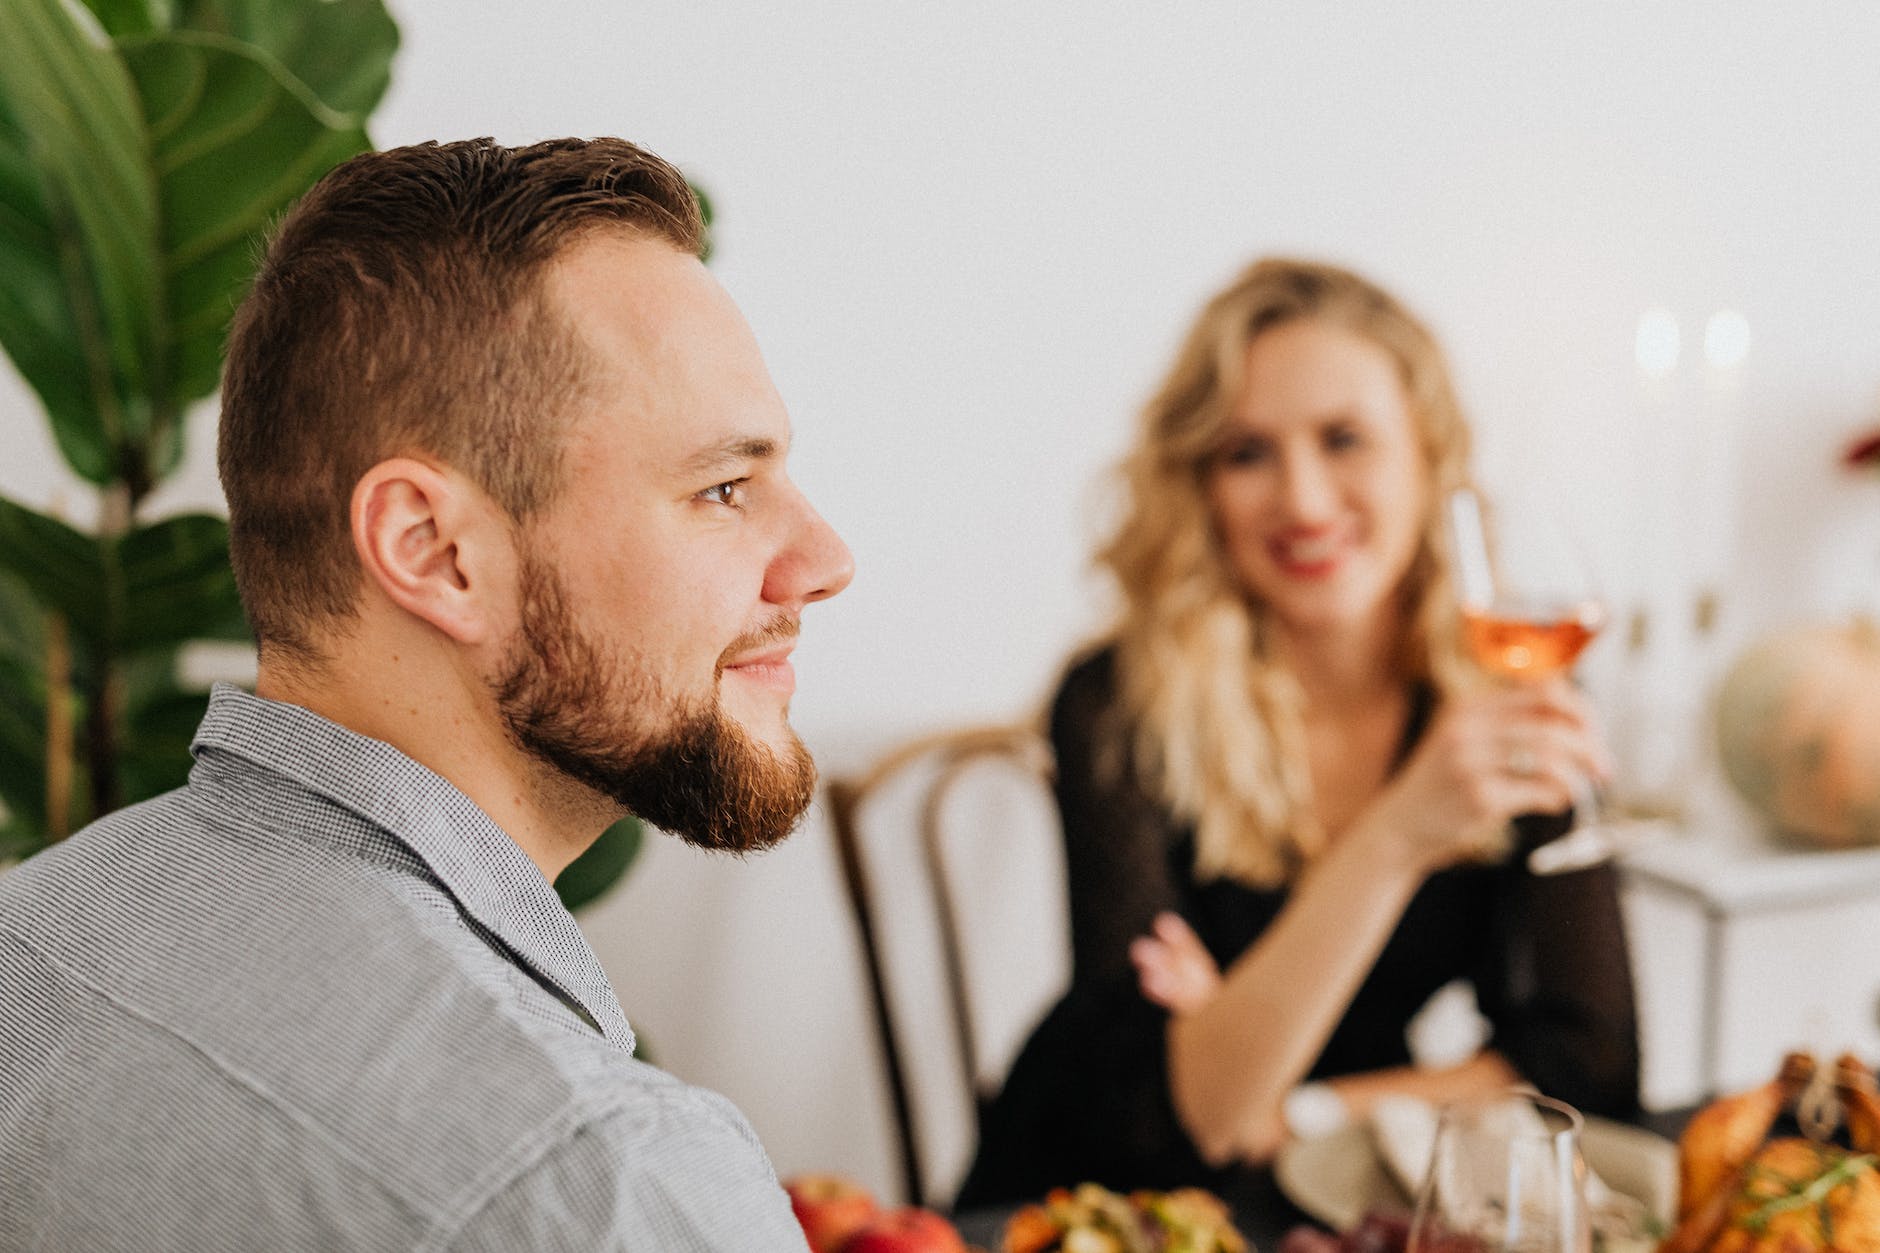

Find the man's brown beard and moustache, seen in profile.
[{"left": 494, "top": 551, "right": 816, "bottom": 854}]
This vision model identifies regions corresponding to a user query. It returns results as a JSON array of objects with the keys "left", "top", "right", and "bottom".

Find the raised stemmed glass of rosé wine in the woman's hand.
[{"left": 1448, "top": 487, "right": 1619, "bottom": 875}]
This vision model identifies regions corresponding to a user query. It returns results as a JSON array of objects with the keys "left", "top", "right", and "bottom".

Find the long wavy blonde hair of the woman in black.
[{"left": 1096, "top": 258, "right": 1468, "bottom": 886}]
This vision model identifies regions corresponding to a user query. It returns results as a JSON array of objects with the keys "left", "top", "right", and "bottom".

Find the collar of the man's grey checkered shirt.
[{"left": 190, "top": 683, "right": 634, "bottom": 1052}]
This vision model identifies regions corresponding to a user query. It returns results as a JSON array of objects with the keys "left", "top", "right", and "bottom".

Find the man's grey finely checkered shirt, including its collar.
[{"left": 0, "top": 687, "right": 805, "bottom": 1253}]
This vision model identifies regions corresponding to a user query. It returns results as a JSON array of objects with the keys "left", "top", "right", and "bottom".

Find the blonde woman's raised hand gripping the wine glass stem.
[{"left": 1367, "top": 679, "right": 1611, "bottom": 875}]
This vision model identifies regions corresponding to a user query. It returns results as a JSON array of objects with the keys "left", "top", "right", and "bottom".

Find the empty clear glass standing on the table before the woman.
[{"left": 1408, "top": 1091, "right": 1592, "bottom": 1253}]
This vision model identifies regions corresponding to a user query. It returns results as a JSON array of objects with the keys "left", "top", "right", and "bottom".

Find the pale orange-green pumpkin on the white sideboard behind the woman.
[{"left": 1716, "top": 623, "right": 1880, "bottom": 849}]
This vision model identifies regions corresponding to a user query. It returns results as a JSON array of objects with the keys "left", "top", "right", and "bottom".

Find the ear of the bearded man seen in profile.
[{"left": 352, "top": 457, "right": 513, "bottom": 645}]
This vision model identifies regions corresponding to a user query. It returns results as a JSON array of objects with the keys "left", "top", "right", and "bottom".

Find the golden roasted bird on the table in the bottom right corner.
[{"left": 1658, "top": 1054, "right": 1880, "bottom": 1253}]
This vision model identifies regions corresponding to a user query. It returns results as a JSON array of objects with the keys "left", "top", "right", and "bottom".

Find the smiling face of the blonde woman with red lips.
[{"left": 1203, "top": 320, "right": 1429, "bottom": 632}]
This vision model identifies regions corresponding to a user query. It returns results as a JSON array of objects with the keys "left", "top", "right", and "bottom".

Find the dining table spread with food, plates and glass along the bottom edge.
[{"left": 786, "top": 1052, "right": 1880, "bottom": 1253}]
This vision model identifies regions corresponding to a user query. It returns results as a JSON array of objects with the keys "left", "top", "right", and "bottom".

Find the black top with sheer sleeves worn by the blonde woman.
[{"left": 957, "top": 649, "right": 1637, "bottom": 1206}]
